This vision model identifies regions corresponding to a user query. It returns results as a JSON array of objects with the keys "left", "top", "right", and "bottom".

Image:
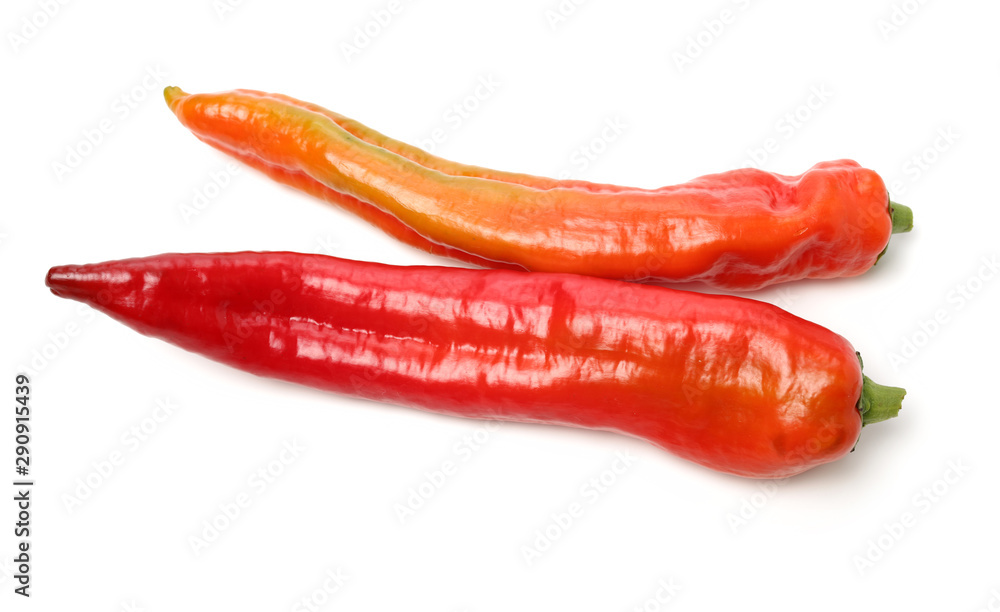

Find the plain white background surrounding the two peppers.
[{"left": 0, "top": 0, "right": 1000, "bottom": 611}]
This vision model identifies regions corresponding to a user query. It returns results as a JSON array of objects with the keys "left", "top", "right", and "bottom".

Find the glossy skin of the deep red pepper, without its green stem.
[{"left": 46, "top": 252, "right": 902, "bottom": 478}]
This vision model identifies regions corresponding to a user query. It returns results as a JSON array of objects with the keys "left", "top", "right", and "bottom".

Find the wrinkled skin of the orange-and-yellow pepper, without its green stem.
[{"left": 164, "top": 87, "right": 909, "bottom": 290}]
